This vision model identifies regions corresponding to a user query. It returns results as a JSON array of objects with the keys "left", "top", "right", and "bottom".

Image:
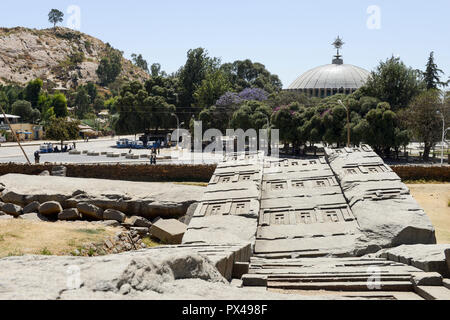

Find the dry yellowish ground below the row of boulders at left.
[{"left": 0, "top": 219, "right": 119, "bottom": 258}]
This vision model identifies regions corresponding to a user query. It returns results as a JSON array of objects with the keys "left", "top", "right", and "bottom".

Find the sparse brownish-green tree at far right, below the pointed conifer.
[{"left": 404, "top": 90, "right": 442, "bottom": 161}]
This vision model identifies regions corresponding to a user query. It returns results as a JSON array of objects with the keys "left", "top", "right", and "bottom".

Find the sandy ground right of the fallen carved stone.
[{"left": 408, "top": 183, "right": 450, "bottom": 244}]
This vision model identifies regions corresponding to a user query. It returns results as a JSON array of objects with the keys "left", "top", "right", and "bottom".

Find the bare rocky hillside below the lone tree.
[{"left": 0, "top": 27, "right": 148, "bottom": 88}]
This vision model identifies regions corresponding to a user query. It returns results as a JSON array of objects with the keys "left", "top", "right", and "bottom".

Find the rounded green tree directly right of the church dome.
[{"left": 360, "top": 57, "right": 424, "bottom": 112}]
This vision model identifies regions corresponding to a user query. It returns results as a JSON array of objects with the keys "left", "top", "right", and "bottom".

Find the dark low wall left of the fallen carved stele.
[{"left": 0, "top": 163, "right": 216, "bottom": 182}]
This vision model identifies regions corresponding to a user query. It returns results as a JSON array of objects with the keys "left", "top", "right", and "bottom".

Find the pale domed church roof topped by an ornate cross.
[{"left": 287, "top": 37, "right": 370, "bottom": 98}]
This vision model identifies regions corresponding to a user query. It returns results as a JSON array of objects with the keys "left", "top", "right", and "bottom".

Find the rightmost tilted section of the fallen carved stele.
[{"left": 325, "top": 146, "right": 436, "bottom": 255}]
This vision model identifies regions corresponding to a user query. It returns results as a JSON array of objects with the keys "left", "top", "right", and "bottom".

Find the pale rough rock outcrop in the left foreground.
[{"left": 0, "top": 247, "right": 324, "bottom": 300}]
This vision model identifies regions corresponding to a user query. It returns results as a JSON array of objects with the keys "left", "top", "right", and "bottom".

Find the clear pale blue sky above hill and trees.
[{"left": 0, "top": 0, "right": 450, "bottom": 88}]
